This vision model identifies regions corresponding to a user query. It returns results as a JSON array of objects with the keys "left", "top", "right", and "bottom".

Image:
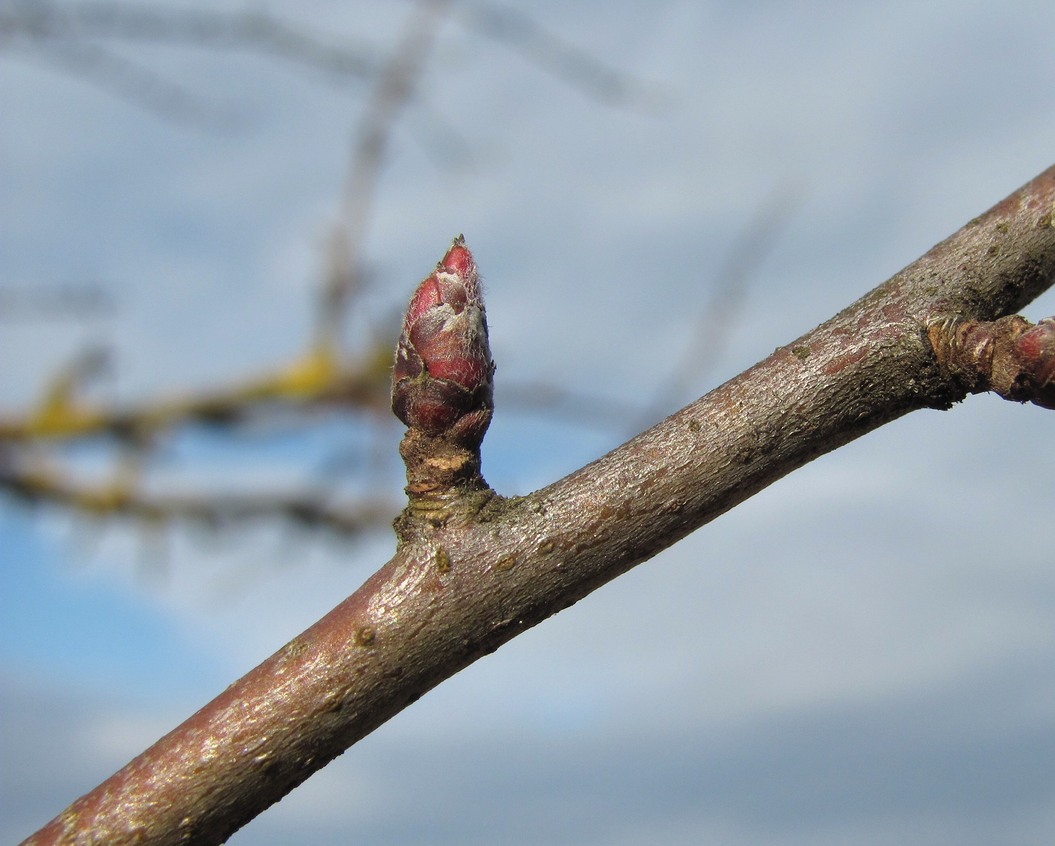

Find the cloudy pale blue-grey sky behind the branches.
[{"left": 0, "top": 0, "right": 1055, "bottom": 846}]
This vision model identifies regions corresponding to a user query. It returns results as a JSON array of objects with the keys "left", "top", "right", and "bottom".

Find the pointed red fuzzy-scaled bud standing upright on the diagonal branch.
[{"left": 392, "top": 235, "right": 495, "bottom": 445}]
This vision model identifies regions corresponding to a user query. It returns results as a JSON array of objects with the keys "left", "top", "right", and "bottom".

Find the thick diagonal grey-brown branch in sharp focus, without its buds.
[{"left": 26, "top": 161, "right": 1055, "bottom": 844}]
